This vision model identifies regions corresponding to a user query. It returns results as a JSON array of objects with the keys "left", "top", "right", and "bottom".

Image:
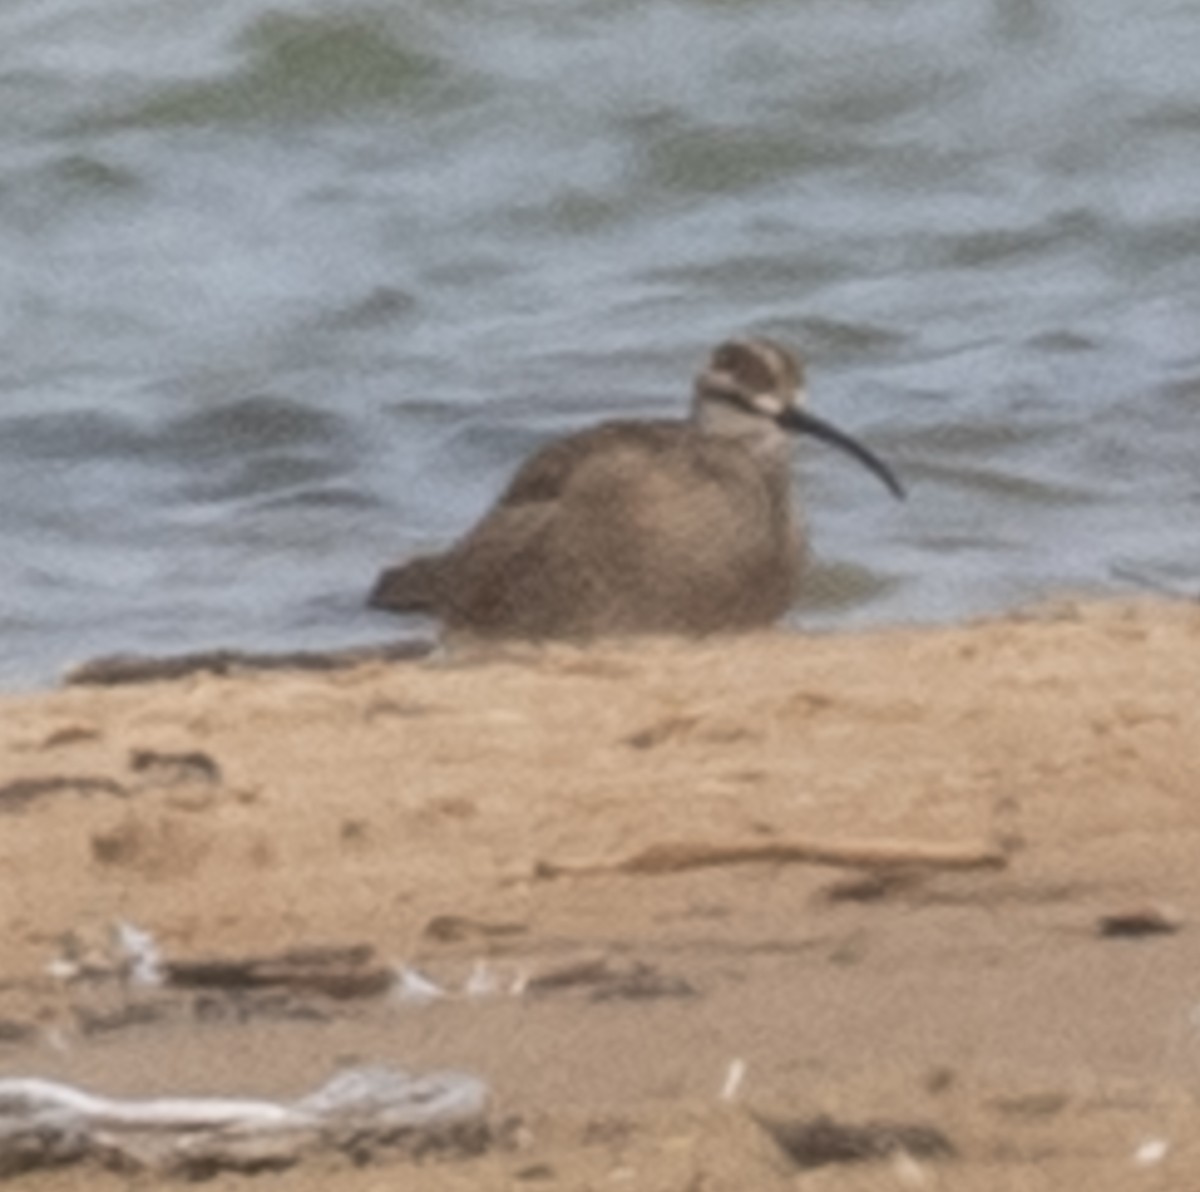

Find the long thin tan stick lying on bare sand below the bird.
[{"left": 534, "top": 838, "right": 1008, "bottom": 877}]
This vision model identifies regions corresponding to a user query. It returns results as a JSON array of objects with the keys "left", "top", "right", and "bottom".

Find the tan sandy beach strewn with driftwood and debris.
[{"left": 0, "top": 601, "right": 1200, "bottom": 1192}]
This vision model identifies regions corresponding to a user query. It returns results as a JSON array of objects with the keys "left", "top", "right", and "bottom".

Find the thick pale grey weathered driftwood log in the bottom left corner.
[{"left": 0, "top": 1066, "right": 488, "bottom": 1179}]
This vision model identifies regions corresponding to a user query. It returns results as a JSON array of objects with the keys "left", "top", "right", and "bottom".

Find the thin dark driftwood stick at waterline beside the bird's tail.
[{"left": 62, "top": 640, "right": 436, "bottom": 687}]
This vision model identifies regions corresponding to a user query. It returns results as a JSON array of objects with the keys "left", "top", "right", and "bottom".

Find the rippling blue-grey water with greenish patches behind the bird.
[{"left": 0, "top": 0, "right": 1200, "bottom": 685}]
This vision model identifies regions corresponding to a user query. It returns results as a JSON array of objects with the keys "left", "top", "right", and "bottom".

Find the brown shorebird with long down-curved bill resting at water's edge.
[{"left": 368, "top": 339, "right": 904, "bottom": 639}]
